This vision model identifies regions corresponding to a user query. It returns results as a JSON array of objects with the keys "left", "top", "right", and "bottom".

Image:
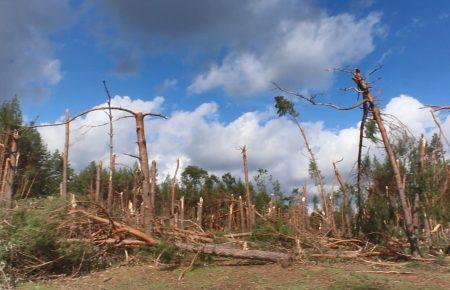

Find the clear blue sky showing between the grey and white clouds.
[{"left": 6, "top": 1, "right": 450, "bottom": 126}]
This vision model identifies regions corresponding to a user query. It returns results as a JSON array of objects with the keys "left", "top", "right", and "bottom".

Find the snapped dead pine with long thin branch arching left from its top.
[{"left": 27, "top": 106, "right": 167, "bottom": 229}]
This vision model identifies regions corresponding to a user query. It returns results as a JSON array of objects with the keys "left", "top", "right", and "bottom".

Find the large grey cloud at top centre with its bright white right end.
[{"left": 96, "top": 0, "right": 382, "bottom": 96}]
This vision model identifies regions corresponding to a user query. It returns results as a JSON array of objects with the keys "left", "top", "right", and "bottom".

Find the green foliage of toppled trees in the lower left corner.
[{"left": 0, "top": 197, "right": 118, "bottom": 280}]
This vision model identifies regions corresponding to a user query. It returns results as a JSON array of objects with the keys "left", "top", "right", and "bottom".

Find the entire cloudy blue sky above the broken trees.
[{"left": 0, "top": 0, "right": 450, "bottom": 193}]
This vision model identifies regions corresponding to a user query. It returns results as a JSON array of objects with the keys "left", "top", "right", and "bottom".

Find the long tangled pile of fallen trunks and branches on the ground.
[{"left": 70, "top": 201, "right": 440, "bottom": 266}]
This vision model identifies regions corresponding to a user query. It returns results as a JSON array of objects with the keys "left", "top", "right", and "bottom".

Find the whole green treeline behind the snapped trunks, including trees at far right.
[{"left": 0, "top": 79, "right": 450, "bottom": 254}]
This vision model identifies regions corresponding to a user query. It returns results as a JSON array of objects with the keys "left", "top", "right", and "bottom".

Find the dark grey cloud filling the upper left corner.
[{"left": 0, "top": 0, "right": 71, "bottom": 99}]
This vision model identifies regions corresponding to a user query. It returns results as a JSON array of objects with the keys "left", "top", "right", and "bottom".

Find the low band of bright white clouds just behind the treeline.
[{"left": 39, "top": 95, "right": 450, "bottom": 195}]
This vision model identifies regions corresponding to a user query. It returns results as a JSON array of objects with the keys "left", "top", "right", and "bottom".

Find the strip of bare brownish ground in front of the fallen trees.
[{"left": 19, "top": 258, "right": 450, "bottom": 290}]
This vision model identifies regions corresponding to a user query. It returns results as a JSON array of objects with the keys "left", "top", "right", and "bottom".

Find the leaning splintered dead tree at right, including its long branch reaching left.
[{"left": 275, "top": 69, "right": 422, "bottom": 255}]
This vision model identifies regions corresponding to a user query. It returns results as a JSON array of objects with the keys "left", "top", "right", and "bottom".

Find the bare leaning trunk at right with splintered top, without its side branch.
[{"left": 353, "top": 69, "right": 419, "bottom": 255}]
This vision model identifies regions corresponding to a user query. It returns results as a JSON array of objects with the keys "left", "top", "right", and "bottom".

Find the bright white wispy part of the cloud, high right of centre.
[{"left": 189, "top": 14, "right": 380, "bottom": 95}]
